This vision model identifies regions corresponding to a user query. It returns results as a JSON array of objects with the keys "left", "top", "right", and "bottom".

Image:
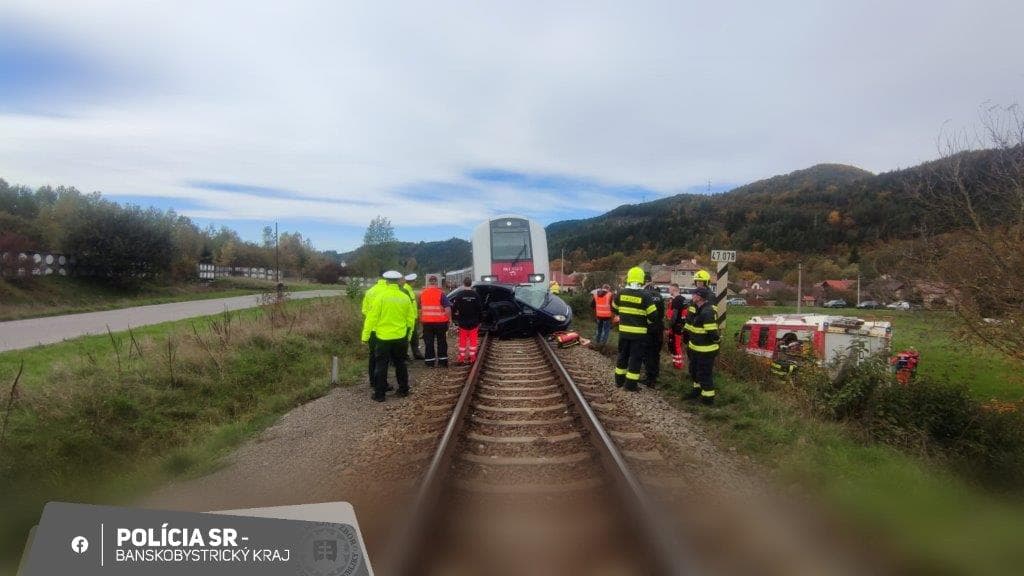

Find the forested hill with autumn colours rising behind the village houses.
[{"left": 547, "top": 153, "right": 985, "bottom": 260}]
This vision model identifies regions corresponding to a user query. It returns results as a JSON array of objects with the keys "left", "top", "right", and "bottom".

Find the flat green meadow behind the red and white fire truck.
[{"left": 726, "top": 306, "right": 1024, "bottom": 402}]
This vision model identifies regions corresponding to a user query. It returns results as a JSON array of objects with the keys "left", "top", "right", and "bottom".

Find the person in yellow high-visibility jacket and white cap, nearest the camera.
[{"left": 361, "top": 270, "right": 416, "bottom": 402}]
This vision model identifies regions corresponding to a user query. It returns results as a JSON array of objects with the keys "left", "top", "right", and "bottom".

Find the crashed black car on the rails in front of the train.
[{"left": 449, "top": 283, "right": 572, "bottom": 338}]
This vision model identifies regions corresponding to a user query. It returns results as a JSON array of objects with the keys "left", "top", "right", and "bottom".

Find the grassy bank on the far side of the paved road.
[{"left": 0, "top": 278, "right": 327, "bottom": 322}]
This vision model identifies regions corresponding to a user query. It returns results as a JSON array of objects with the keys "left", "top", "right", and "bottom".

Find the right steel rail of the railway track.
[{"left": 537, "top": 334, "right": 699, "bottom": 576}]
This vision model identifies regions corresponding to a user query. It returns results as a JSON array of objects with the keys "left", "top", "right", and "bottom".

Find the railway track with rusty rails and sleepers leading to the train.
[{"left": 388, "top": 337, "right": 691, "bottom": 575}]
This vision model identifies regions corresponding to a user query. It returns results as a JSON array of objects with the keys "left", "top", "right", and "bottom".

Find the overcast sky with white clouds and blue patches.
[{"left": 0, "top": 0, "right": 1024, "bottom": 250}]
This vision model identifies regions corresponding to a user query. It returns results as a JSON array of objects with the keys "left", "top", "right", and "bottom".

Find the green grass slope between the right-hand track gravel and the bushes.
[{"left": 662, "top": 368, "right": 1024, "bottom": 574}]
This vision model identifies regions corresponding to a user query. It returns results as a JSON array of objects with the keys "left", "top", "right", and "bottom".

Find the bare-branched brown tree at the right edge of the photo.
[{"left": 907, "top": 106, "right": 1024, "bottom": 361}]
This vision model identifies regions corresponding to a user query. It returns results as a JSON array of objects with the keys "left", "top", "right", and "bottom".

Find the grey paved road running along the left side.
[{"left": 0, "top": 290, "right": 341, "bottom": 352}]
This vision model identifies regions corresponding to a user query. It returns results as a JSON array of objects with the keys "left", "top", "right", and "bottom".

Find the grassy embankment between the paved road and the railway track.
[{"left": 0, "top": 297, "right": 365, "bottom": 573}]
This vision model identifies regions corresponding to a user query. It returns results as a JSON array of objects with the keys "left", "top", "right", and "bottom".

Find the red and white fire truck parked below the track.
[{"left": 738, "top": 314, "right": 892, "bottom": 375}]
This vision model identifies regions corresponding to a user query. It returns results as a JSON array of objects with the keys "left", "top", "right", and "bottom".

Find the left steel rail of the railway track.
[{"left": 386, "top": 335, "right": 492, "bottom": 576}]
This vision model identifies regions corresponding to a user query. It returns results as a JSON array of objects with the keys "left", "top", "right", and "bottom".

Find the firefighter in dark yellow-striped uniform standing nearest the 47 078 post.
[{"left": 683, "top": 287, "right": 721, "bottom": 405}]
